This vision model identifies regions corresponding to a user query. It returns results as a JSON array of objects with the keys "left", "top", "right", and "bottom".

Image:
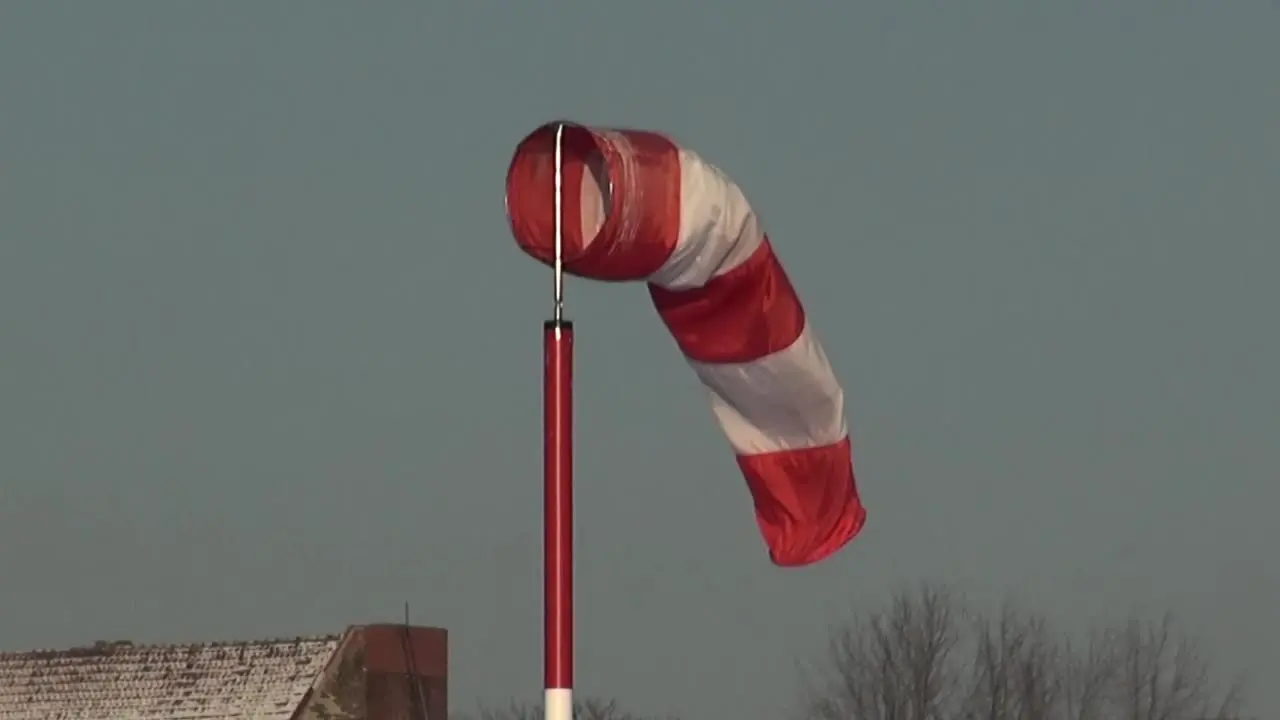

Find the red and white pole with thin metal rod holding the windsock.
[{"left": 543, "top": 124, "right": 573, "bottom": 720}]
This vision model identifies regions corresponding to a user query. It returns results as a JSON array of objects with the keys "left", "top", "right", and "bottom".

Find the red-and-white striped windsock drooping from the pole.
[{"left": 507, "top": 123, "right": 867, "bottom": 566}]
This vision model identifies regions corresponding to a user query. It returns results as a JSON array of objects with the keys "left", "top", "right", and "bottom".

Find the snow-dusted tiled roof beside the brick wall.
[{"left": 0, "top": 635, "right": 340, "bottom": 720}]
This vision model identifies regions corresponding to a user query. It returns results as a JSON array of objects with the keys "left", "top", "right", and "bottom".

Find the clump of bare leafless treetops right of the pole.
[{"left": 801, "top": 585, "right": 1238, "bottom": 720}]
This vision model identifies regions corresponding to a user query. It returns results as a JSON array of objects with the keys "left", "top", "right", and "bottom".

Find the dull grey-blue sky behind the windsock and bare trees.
[{"left": 0, "top": 0, "right": 1280, "bottom": 720}]
